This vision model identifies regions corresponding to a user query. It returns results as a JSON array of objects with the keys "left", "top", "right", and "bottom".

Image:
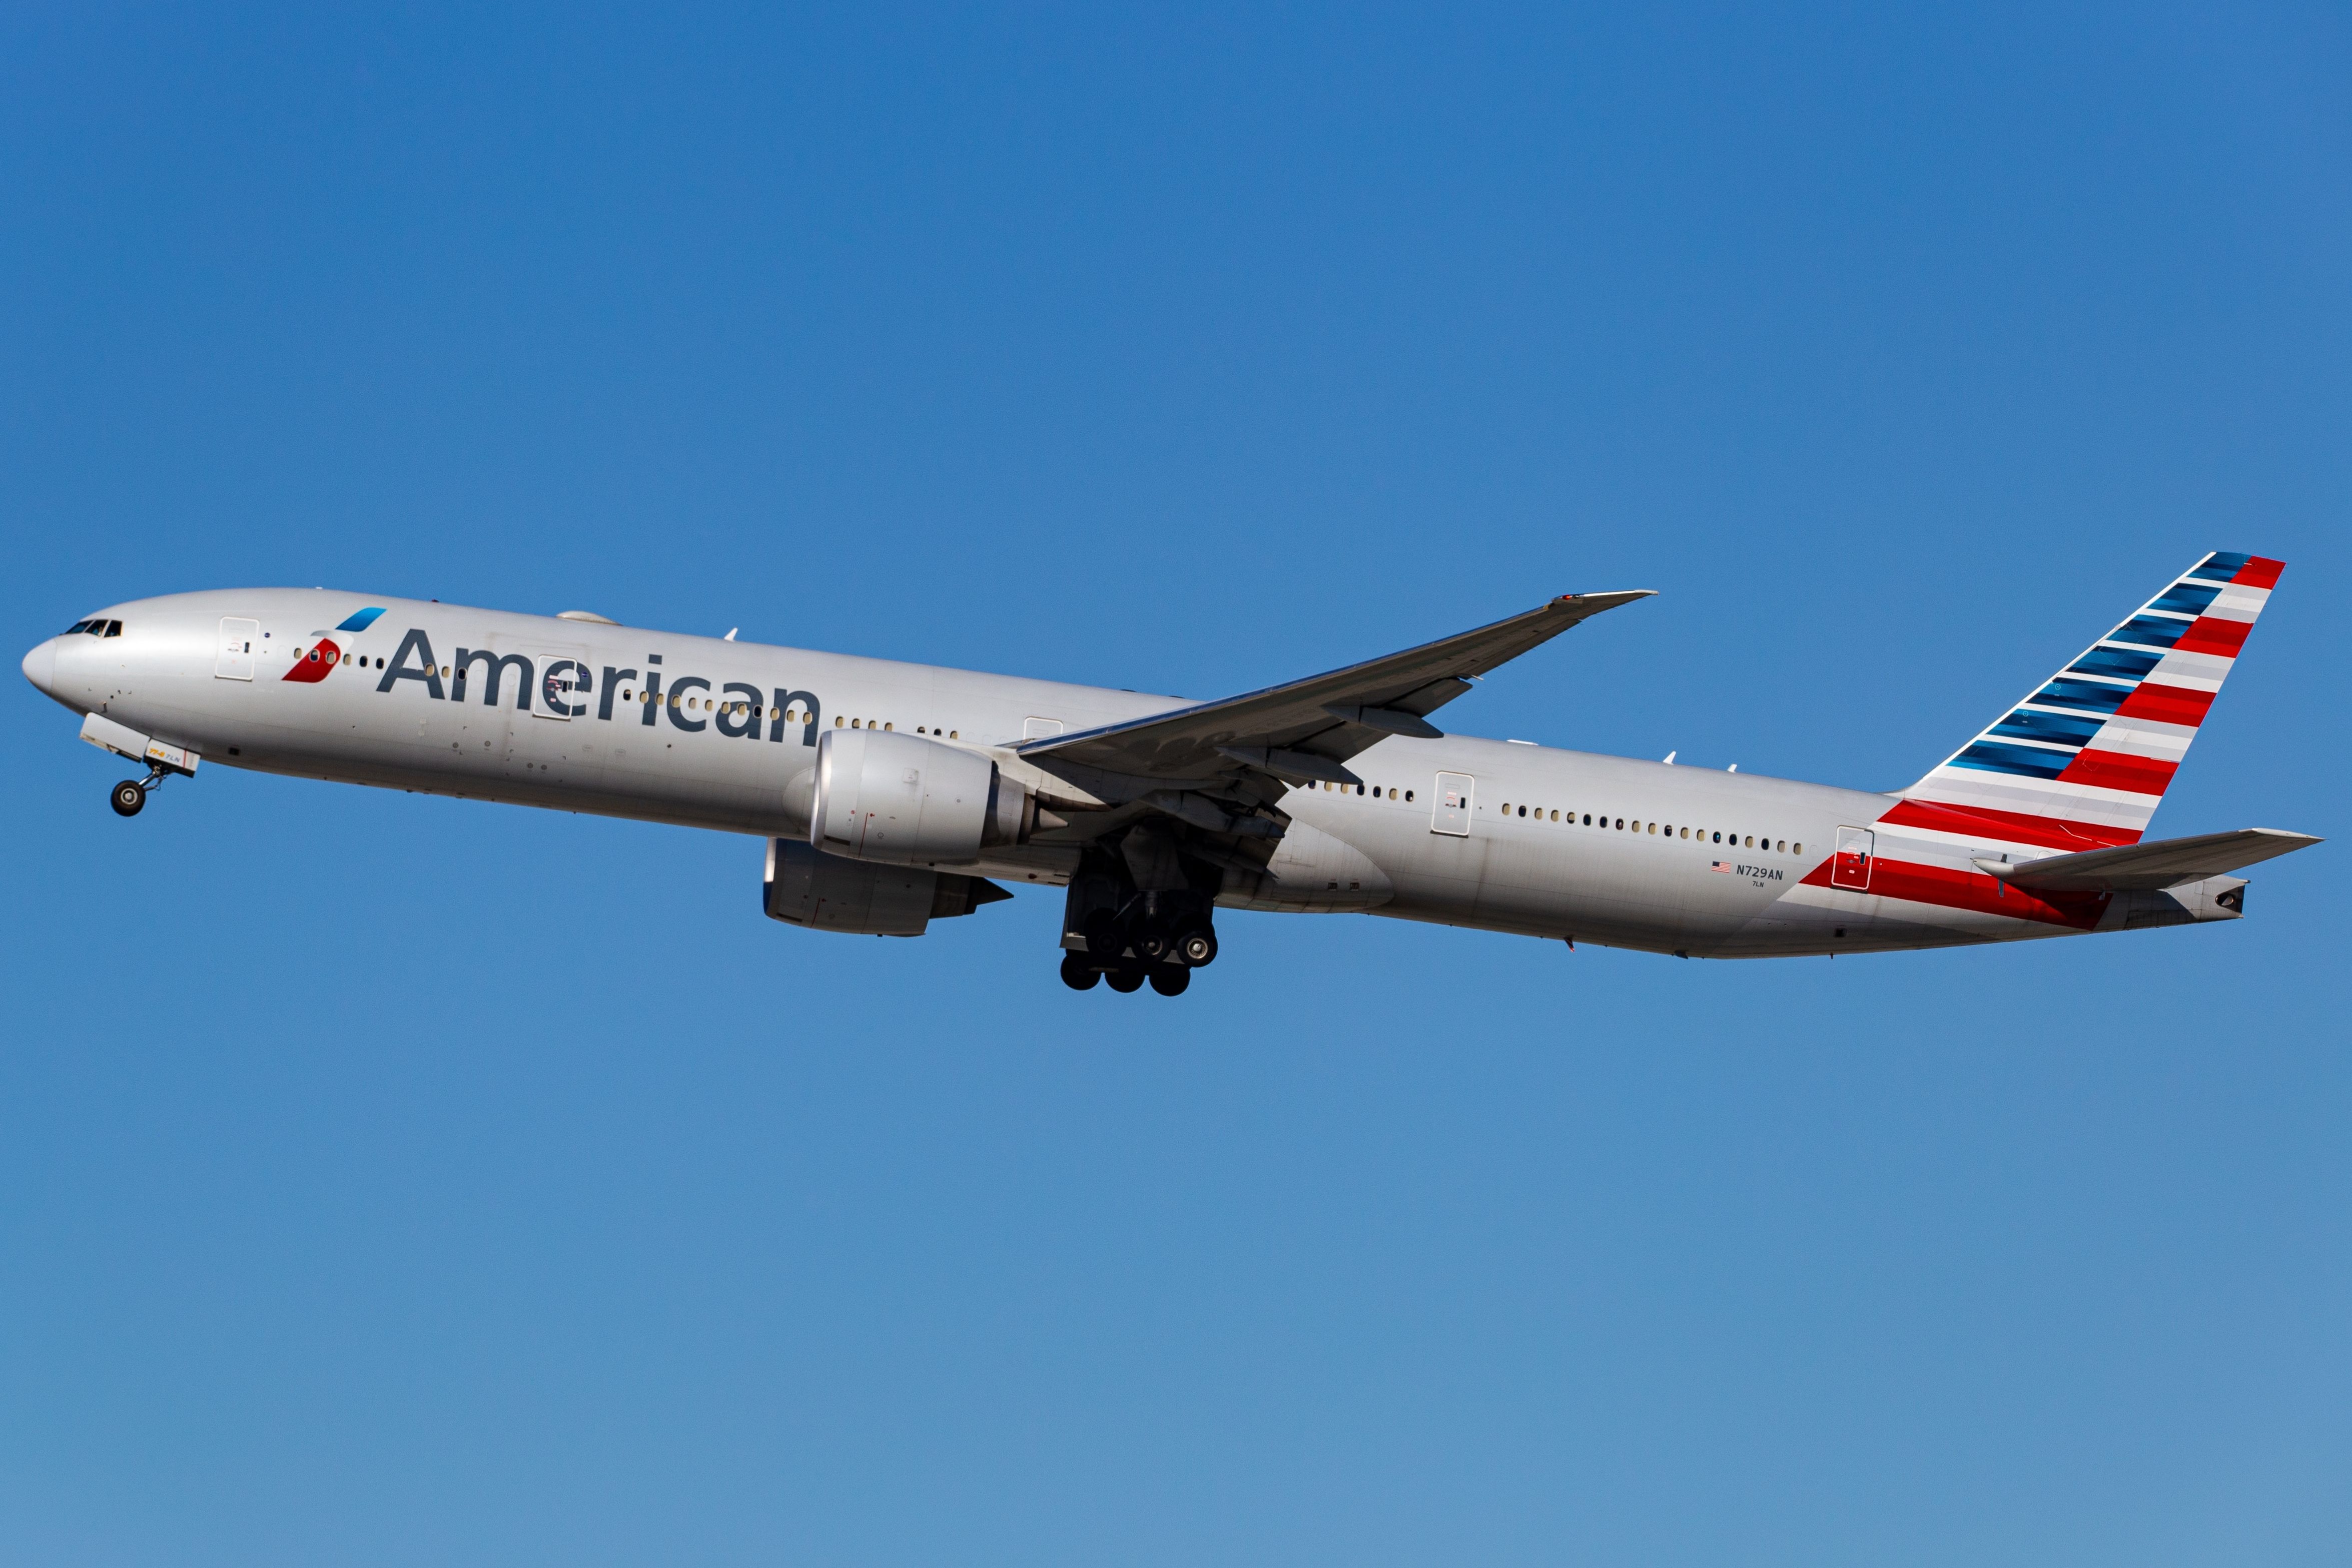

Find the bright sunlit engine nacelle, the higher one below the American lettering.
[{"left": 809, "top": 729, "right": 1037, "bottom": 865}]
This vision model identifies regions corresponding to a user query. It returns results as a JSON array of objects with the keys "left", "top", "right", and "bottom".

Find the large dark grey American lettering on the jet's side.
[{"left": 371, "top": 628, "right": 823, "bottom": 745}]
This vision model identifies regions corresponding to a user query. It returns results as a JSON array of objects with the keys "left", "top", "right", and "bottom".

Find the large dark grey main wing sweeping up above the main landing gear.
[{"left": 1019, "top": 588, "right": 1651, "bottom": 788}]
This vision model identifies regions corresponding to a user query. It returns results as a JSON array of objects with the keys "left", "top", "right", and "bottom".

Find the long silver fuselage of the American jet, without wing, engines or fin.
[{"left": 24, "top": 588, "right": 2227, "bottom": 957}]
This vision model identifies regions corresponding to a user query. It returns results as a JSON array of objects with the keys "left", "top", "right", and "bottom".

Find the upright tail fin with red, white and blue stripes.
[{"left": 1882, "top": 552, "right": 2284, "bottom": 851}]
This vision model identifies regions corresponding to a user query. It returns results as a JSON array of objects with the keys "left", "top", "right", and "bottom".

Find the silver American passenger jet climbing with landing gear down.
[{"left": 24, "top": 552, "right": 2319, "bottom": 997}]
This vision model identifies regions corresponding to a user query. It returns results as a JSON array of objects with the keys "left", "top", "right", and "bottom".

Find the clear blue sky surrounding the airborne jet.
[{"left": 0, "top": 5, "right": 2352, "bottom": 1568}]
